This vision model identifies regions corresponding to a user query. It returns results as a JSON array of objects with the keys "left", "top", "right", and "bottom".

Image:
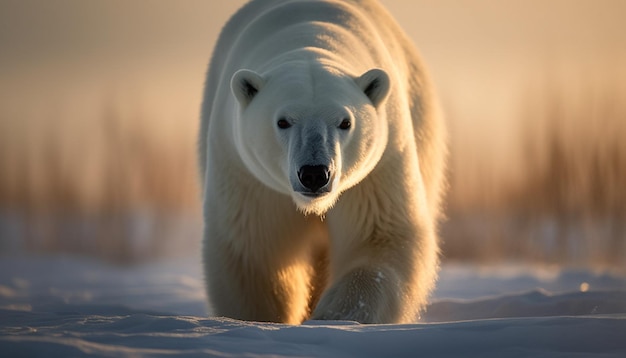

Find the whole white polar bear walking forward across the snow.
[{"left": 199, "top": 0, "right": 446, "bottom": 324}]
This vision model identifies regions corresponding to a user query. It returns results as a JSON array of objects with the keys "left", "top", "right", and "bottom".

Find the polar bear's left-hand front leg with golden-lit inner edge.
[{"left": 204, "top": 179, "right": 326, "bottom": 324}]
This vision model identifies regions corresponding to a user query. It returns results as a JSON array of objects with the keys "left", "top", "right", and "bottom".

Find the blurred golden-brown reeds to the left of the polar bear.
[{"left": 0, "top": 101, "right": 200, "bottom": 262}]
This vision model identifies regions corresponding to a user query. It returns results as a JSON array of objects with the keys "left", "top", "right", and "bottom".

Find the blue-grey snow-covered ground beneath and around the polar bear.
[{"left": 0, "top": 256, "right": 626, "bottom": 357}]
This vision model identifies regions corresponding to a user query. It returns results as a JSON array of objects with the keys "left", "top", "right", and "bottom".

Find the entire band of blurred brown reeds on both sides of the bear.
[{"left": 0, "top": 74, "right": 626, "bottom": 268}]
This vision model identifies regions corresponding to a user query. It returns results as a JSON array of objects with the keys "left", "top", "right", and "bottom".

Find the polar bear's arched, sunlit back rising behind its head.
[{"left": 199, "top": 0, "right": 446, "bottom": 216}]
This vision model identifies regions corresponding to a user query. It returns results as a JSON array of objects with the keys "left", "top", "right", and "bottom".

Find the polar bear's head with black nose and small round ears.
[{"left": 231, "top": 65, "right": 390, "bottom": 215}]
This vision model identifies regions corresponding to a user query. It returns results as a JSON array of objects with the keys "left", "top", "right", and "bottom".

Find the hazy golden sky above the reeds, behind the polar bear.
[{"left": 0, "top": 0, "right": 626, "bottom": 122}]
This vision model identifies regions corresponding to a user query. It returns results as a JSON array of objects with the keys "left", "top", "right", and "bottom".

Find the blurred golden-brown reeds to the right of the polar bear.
[{"left": 442, "top": 72, "right": 626, "bottom": 270}]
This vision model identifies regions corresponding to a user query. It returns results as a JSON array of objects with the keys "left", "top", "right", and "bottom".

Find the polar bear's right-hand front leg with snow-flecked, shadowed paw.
[{"left": 311, "top": 175, "right": 438, "bottom": 323}]
